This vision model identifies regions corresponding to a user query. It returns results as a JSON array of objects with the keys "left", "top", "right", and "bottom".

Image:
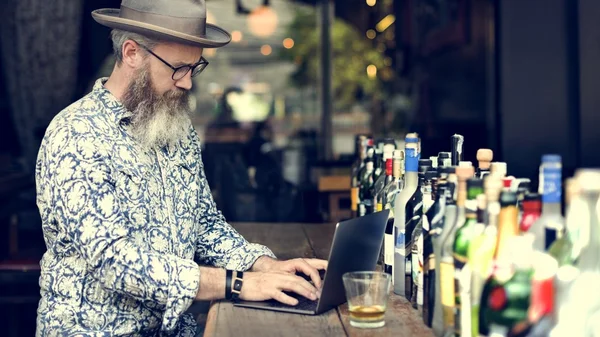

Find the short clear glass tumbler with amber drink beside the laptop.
[{"left": 342, "top": 271, "right": 391, "bottom": 328}]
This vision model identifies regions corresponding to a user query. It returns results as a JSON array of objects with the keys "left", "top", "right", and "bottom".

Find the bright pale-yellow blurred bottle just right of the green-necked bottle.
[{"left": 468, "top": 174, "right": 502, "bottom": 336}]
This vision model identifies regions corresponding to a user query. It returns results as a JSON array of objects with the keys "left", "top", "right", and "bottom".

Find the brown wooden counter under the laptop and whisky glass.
[{"left": 204, "top": 223, "right": 433, "bottom": 337}]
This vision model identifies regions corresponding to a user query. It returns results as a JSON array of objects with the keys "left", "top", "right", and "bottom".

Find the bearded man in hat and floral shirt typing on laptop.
[{"left": 36, "top": 0, "right": 326, "bottom": 336}]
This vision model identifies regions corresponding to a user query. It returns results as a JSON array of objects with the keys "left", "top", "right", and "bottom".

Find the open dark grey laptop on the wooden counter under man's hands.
[{"left": 234, "top": 210, "right": 389, "bottom": 315}]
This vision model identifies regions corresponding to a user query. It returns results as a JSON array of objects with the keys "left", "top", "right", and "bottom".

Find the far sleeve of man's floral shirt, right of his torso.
[{"left": 194, "top": 131, "right": 275, "bottom": 271}]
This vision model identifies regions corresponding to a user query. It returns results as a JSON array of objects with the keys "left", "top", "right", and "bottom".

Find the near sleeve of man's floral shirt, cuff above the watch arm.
[{"left": 44, "top": 132, "right": 200, "bottom": 330}]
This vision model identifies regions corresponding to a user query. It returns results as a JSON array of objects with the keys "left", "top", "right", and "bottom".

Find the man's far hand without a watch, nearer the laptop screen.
[{"left": 252, "top": 256, "right": 327, "bottom": 289}]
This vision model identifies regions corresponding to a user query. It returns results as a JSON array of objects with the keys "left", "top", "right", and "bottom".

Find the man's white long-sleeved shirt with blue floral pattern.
[{"left": 36, "top": 78, "right": 274, "bottom": 336}]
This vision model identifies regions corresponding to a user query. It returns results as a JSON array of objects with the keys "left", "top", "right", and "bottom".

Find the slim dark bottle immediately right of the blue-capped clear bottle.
[{"left": 404, "top": 159, "right": 431, "bottom": 298}]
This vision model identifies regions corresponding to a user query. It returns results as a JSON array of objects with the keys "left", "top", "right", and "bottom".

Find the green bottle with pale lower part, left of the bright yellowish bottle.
[{"left": 453, "top": 178, "right": 483, "bottom": 337}]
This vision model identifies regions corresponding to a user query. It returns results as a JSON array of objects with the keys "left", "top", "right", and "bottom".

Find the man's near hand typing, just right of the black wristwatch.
[{"left": 240, "top": 272, "right": 318, "bottom": 305}]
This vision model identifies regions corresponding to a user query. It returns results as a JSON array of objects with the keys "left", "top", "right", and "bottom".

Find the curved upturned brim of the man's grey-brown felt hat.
[{"left": 92, "top": 8, "right": 231, "bottom": 48}]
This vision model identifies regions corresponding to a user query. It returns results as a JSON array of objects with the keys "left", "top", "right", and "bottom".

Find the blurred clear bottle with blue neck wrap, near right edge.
[{"left": 529, "top": 154, "right": 565, "bottom": 251}]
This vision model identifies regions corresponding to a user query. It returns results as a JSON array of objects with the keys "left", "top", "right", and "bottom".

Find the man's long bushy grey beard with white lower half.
[{"left": 123, "top": 69, "right": 191, "bottom": 150}]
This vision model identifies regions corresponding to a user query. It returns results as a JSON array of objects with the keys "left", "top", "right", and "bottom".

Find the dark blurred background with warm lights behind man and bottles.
[{"left": 0, "top": 0, "right": 600, "bottom": 336}]
